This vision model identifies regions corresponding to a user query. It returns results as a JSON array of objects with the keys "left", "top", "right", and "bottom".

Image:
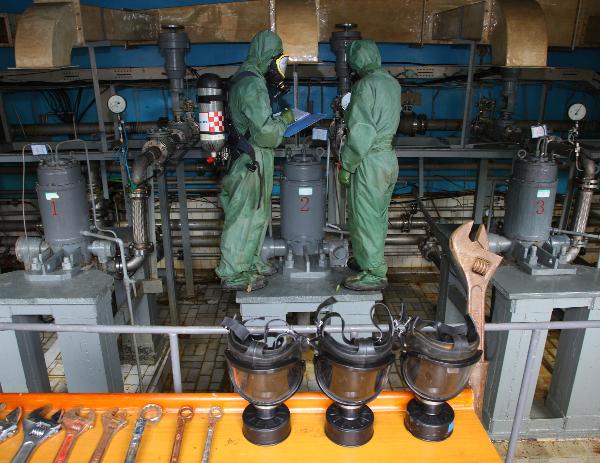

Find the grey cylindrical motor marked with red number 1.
[{"left": 36, "top": 157, "right": 90, "bottom": 256}]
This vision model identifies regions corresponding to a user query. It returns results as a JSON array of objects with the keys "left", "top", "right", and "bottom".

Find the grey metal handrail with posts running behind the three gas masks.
[{"left": 0, "top": 320, "right": 600, "bottom": 463}]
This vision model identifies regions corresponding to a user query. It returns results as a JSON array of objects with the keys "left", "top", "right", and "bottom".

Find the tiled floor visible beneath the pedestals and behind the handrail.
[{"left": 44, "top": 274, "right": 600, "bottom": 463}]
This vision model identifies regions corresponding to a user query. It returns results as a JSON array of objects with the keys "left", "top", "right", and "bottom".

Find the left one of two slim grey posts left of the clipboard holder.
[{"left": 156, "top": 172, "right": 179, "bottom": 325}]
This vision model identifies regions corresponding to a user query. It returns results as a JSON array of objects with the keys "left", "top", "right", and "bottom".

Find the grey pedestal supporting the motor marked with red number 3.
[{"left": 483, "top": 266, "right": 600, "bottom": 439}]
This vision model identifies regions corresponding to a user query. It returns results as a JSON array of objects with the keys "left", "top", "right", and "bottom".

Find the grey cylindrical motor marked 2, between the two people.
[{"left": 281, "top": 154, "right": 325, "bottom": 256}]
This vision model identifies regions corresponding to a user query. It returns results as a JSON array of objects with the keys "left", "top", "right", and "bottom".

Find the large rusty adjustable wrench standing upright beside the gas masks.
[{"left": 449, "top": 221, "right": 502, "bottom": 418}]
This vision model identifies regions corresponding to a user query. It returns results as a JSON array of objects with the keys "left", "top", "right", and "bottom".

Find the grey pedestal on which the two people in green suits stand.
[{"left": 236, "top": 268, "right": 383, "bottom": 338}]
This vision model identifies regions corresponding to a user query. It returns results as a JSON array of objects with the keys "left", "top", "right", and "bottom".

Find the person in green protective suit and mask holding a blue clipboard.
[{"left": 216, "top": 31, "right": 294, "bottom": 291}]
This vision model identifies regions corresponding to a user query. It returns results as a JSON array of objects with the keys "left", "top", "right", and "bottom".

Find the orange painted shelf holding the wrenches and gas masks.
[{"left": 0, "top": 391, "right": 501, "bottom": 463}]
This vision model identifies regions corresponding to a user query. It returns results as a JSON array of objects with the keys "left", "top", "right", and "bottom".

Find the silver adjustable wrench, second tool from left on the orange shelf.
[{"left": 12, "top": 405, "right": 63, "bottom": 463}]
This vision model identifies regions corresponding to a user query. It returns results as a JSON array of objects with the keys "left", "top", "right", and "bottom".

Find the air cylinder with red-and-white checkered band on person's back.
[{"left": 198, "top": 74, "right": 225, "bottom": 154}]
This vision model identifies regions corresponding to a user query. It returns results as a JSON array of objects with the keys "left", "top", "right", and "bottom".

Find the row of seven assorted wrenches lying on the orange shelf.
[{"left": 0, "top": 403, "right": 223, "bottom": 463}]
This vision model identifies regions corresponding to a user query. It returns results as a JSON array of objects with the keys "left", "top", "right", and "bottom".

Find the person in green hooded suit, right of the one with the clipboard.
[{"left": 339, "top": 40, "right": 401, "bottom": 290}]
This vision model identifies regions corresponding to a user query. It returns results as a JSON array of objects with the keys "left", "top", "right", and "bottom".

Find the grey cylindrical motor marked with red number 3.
[{"left": 504, "top": 155, "right": 558, "bottom": 244}]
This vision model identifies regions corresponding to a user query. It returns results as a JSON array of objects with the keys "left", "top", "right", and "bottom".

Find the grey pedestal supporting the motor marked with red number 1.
[{"left": 0, "top": 270, "right": 123, "bottom": 392}]
